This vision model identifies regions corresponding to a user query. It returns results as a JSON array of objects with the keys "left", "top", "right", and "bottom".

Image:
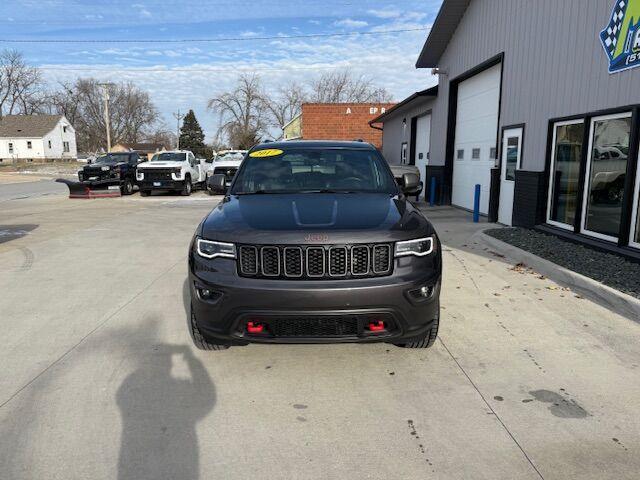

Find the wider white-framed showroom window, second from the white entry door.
[{"left": 581, "top": 112, "right": 631, "bottom": 242}]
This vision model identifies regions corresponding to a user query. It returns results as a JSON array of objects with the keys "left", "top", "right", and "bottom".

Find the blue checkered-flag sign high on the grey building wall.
[{"left": 600, "top": 0, "right": 640, "bottom": 73}]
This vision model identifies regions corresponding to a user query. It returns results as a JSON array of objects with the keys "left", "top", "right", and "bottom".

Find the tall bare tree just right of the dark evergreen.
[{"left": 208, "top": 74, "right": 269, "bottom": 149}]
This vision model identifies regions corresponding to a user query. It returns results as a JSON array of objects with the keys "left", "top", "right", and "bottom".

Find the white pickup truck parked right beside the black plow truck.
[{"left": 136, "top": 150, "right": 211, "bottom": 197}]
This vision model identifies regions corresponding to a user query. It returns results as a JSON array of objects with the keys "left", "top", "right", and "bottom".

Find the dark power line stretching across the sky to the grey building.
[{"left": 0, "top": 27, "right": 428, "bottom": 44}]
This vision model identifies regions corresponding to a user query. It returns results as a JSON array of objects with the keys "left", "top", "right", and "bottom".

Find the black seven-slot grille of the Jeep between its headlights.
[{"left": 238, "top": 243, "right": 393, "bottom": 280}]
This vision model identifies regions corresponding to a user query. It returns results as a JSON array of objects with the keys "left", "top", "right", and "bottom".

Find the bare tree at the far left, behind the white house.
[{"left": 0, "top": 50, "right": 44, "bottom": 118}]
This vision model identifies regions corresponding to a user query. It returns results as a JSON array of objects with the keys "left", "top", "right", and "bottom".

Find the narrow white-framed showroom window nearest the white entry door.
[{"left": 547, "top": 120, "right": 584, "bottom": 230}]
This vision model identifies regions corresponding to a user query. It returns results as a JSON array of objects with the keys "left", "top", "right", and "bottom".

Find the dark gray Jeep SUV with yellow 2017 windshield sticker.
[{"left": 189, "top": 141, "right": 442, "bottom": 350}]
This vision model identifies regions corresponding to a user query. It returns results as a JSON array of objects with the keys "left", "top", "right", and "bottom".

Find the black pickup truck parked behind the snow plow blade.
[{"left": 78, "top": 152, "right": 140, "bottom": 195}]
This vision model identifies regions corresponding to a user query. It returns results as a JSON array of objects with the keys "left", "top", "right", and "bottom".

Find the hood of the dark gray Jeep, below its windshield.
[{"left": 197, "top": 193, "right": 433, "bottom": 244}]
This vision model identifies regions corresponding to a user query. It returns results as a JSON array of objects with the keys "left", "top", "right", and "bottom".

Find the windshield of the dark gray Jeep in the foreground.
[{"left": 231, "top": 148, "right": 398, "bottom": 195}]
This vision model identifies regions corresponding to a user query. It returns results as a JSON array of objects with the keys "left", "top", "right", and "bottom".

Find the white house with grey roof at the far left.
[{"left": 0, "top": 115, "right": 78, "bottom": 163}]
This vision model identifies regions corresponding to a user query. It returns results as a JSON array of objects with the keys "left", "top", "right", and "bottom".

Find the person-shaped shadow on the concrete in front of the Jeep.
[{"left": 116, "top": 318, "right": 216, "bottom": 480}]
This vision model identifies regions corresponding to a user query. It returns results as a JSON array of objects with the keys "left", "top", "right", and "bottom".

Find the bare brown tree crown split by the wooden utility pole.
[{"left": 49, "top": 78, "right": 160, "bottom": 151}]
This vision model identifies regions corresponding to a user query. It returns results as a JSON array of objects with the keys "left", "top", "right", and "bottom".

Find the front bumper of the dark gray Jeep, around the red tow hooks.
[{"left": 188, "top": 249, "right": 442, "bottom": 344}]
